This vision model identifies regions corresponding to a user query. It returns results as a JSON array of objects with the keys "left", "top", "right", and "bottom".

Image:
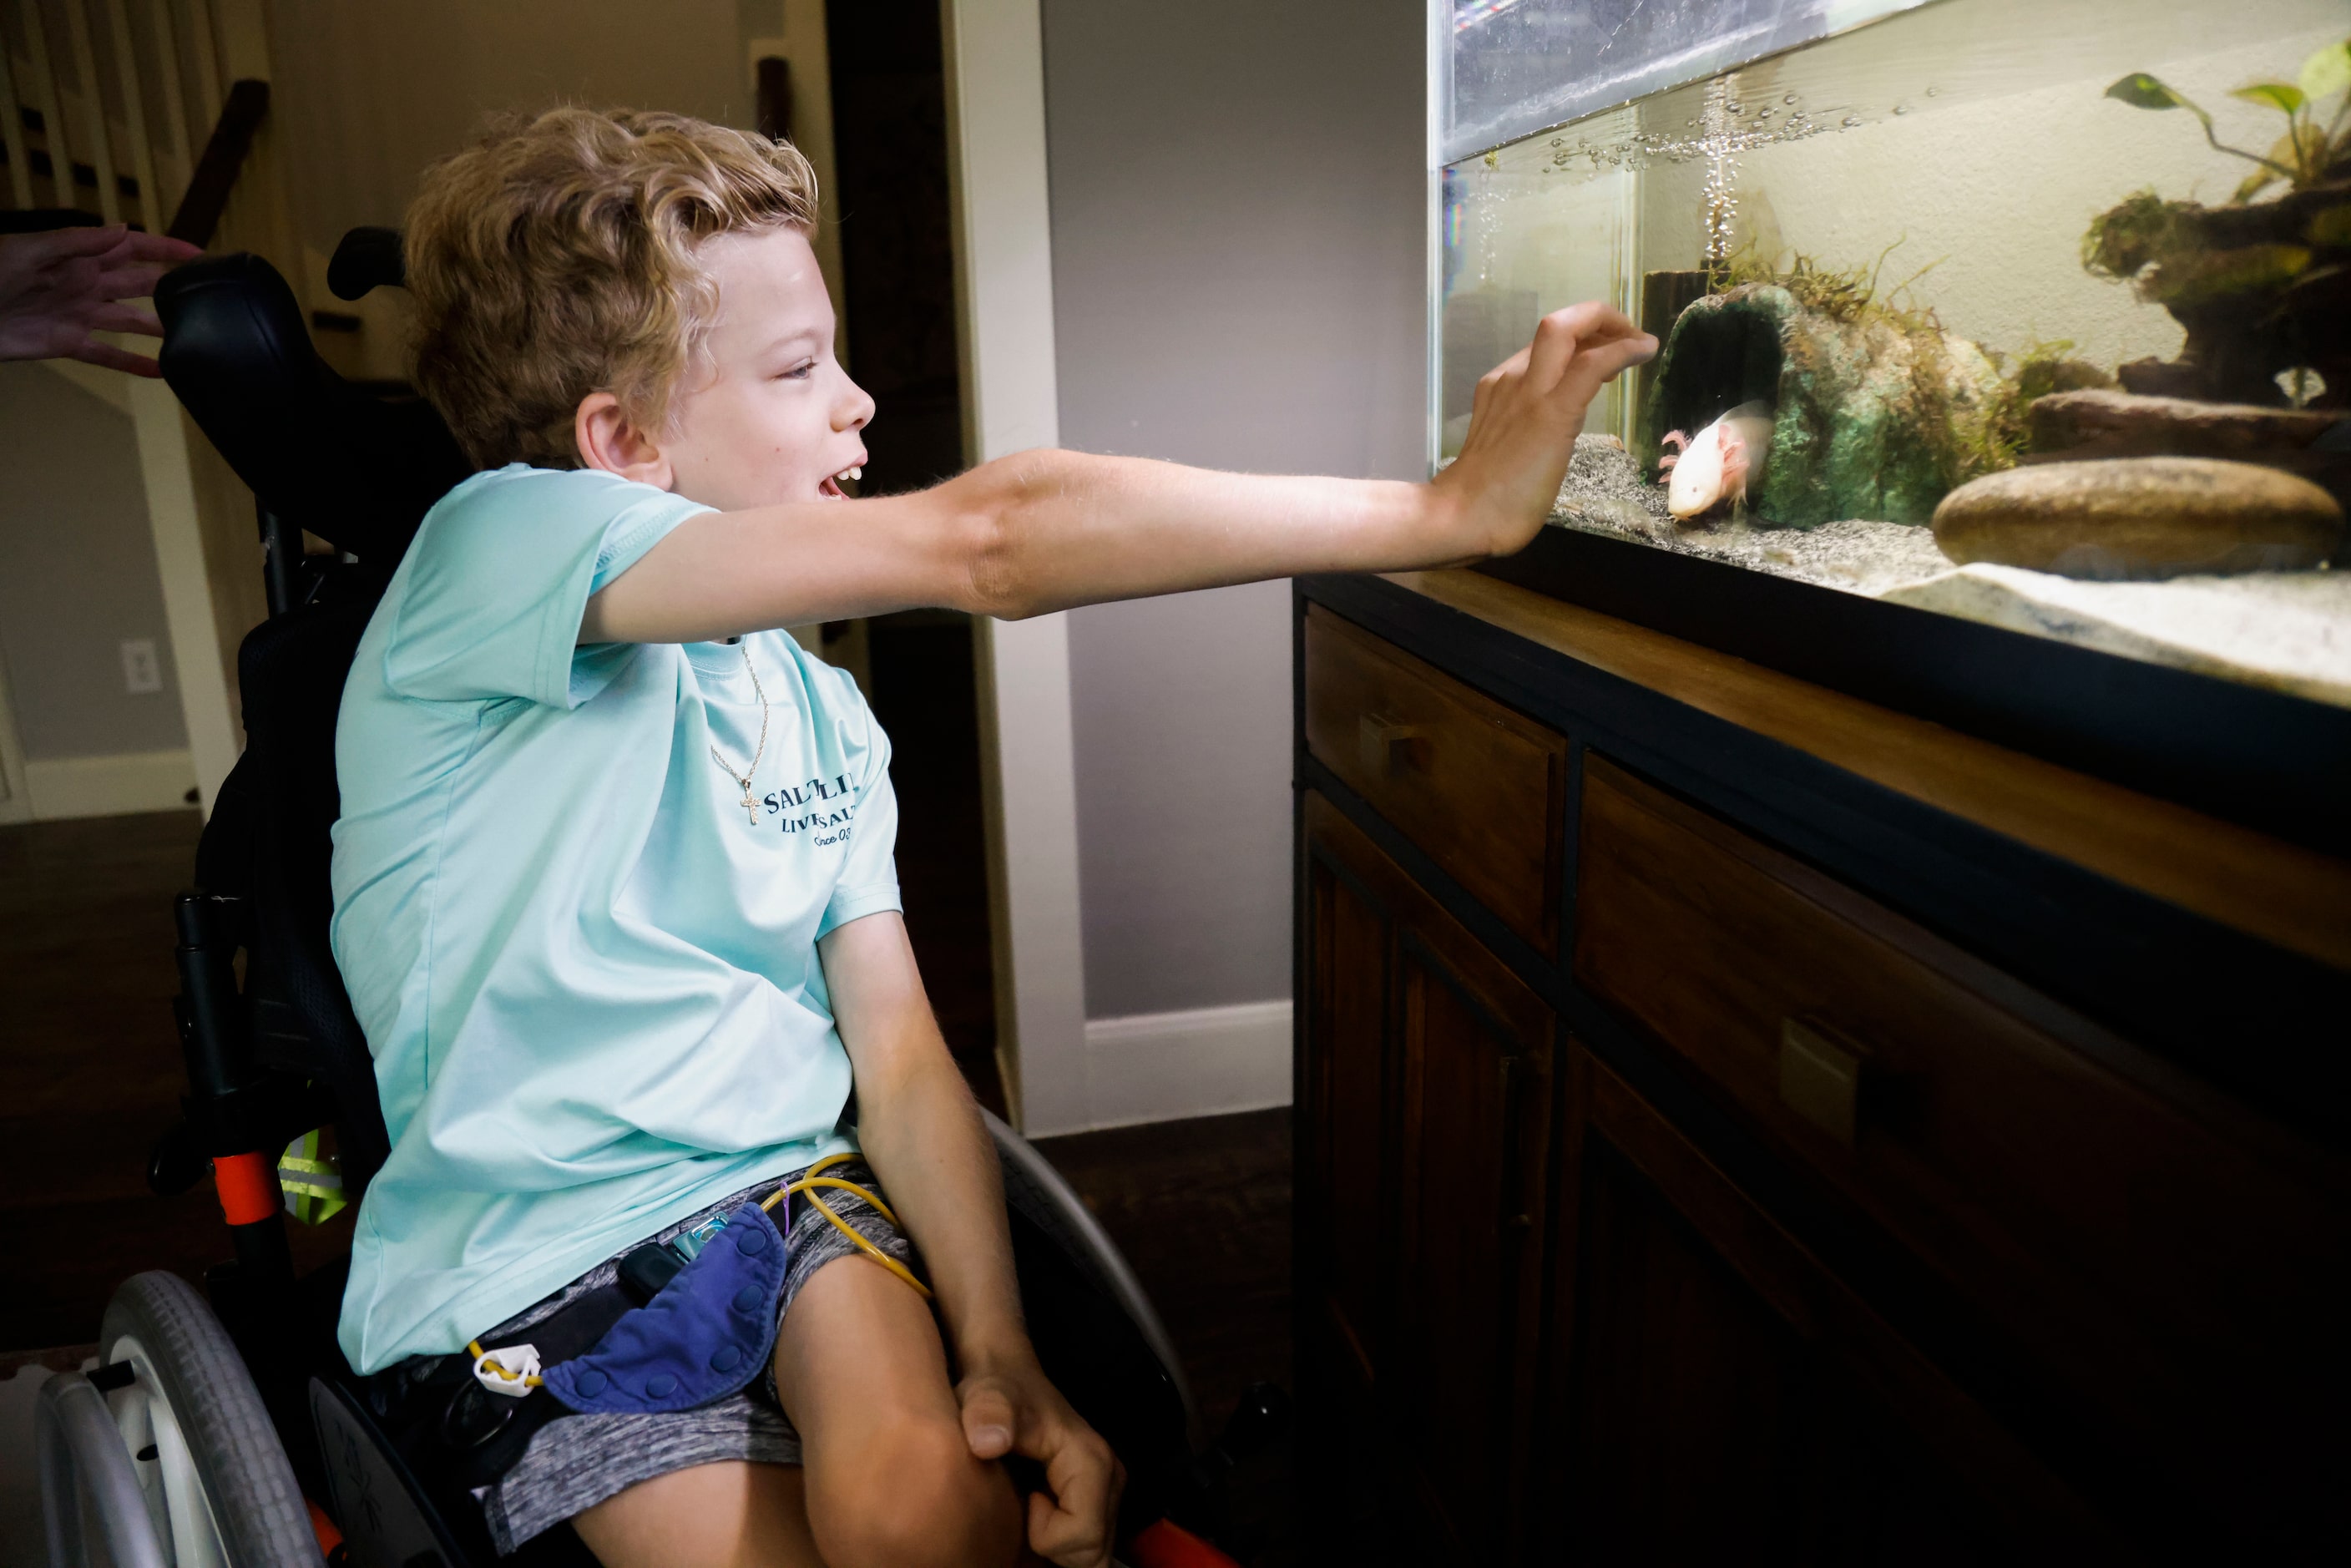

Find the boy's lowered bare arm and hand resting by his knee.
[{"left": 818, "top": 914, "right": 1126, "bottom": 1568}]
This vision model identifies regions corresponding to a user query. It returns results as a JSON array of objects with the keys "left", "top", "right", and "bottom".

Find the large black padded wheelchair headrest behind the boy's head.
[{"left": 155, "top": 254, "right": 473, "bottom": 569}]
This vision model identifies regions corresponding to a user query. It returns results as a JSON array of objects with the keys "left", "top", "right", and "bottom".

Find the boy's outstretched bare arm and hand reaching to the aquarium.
[{"left": 581, "top": 303, "right": 1657, "bottom": 642}]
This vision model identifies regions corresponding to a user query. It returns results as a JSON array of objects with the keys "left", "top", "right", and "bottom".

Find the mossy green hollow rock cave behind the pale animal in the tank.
[{"left": 1641, "top": 282, "right": 2008, "bottom": 529}]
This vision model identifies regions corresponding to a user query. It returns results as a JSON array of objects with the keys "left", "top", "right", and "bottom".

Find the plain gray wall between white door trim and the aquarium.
[{"left": 1044, "top": 0, "right": 1427, "bottom": 1018}]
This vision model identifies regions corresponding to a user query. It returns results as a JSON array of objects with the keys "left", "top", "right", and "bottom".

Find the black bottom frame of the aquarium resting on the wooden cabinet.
[{"left": 1476, "top": 527, "right": 2351, "bottom": 853}]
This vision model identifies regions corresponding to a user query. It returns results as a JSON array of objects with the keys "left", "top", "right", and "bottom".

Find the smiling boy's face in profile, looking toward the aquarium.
[{"left": 660, "top": 228, "right": 875, "bottom": 513}]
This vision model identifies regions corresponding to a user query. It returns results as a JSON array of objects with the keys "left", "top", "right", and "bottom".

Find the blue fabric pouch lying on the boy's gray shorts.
[{"left": 545, "top": 1204, "right": 786, "bottom": 1415}]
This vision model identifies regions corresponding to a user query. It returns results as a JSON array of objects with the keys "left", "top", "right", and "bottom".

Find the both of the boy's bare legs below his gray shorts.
[{"left": 571, "top": 1257, "right": 1020, "bottom": 1568}]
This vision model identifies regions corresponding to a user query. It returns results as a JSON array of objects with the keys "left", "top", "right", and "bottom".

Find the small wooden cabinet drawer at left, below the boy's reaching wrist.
[{"left": 1305, "top": 604, "right": 1568, "bottom": 952}]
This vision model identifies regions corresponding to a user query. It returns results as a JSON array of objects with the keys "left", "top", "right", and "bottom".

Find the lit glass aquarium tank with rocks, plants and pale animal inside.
[{"left": 1429, "top": 0, "right": 2351, "bottom": 719}]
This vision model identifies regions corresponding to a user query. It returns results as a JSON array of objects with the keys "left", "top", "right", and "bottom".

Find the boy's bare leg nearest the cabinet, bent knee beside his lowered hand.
[{"left": 776, "top": 1257, "right": 1020, "bottom": 1568}]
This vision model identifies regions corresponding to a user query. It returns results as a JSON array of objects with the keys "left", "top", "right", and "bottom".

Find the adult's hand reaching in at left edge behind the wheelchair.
[{"left": 0, "top": 223, "right": 205, "bottom": 376}]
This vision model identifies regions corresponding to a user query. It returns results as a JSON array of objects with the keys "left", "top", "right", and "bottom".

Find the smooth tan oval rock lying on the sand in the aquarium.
[{"left": 1935, "top": 458, "right": 2344, "bottom": 580}]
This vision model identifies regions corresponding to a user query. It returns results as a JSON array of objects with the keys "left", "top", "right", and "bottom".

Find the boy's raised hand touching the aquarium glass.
[{"left": 1434, "top": 303, "right": 1657, "bottom": 554}]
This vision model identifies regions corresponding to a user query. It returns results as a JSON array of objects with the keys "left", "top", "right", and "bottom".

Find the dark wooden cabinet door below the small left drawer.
[{"left": 1297, "top": 795, "right": 1552, "bottom": 1561}]
